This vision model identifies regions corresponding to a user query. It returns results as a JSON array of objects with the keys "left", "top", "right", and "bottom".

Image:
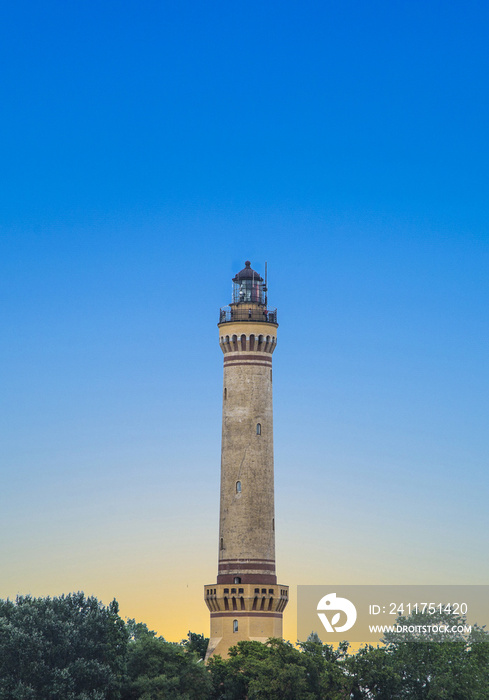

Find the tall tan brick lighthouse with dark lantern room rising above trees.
[{"left": 205, "top": 260, "right": 289, "bottom": 658}]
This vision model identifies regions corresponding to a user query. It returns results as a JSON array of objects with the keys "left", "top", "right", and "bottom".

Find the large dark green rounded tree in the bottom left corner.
[{"left": 0, "top": 593, "right": 127, "bottom": 700}]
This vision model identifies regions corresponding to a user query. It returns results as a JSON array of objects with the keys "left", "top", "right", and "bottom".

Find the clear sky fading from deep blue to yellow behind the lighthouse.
[{"left": 0, "top": 0, "right": 489, "bottom": 640}]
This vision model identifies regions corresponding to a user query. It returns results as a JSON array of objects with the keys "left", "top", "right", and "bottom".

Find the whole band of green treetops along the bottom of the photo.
[{"left": 0, "top": 593, "right": 489, "bottom": 700}]
